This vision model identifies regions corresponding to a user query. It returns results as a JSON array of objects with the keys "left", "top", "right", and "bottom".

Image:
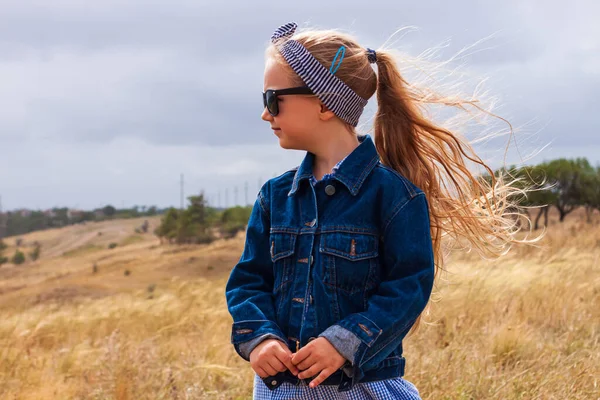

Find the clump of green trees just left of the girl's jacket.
[{"left": 154, "top": 194, "right": 252, "bottom": 244}]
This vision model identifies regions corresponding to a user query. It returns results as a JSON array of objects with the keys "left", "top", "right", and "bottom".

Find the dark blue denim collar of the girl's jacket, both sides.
[{"left": 288, "top": 135, "right": 379, "bottom": 196}]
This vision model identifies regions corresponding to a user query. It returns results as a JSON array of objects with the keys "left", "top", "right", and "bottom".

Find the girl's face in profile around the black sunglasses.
[{"left": 261, "top": 58, "right": 323, "bottom": 151}]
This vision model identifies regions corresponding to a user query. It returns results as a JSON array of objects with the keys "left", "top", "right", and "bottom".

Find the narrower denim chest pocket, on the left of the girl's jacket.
[{"left": 270, "top": 232, "right": 297, "bottom": 294}]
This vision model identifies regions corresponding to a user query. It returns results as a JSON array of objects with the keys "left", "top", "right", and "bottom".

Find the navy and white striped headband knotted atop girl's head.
[{"left": 271, "top": 22, "right": 367, "bottom": 127}]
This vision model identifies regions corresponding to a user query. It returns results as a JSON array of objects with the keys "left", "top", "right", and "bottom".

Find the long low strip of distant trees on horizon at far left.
[{"left": 0, "top": 205, "right": 164, "bottom": 236}]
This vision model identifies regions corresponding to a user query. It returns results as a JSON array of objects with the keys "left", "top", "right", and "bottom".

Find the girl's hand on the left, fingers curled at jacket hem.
[{"left": 250, "top": 339, "right": 299, "bottom": 378}]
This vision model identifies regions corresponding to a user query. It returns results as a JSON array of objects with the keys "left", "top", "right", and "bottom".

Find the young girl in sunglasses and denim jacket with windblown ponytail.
[{"left": 226, "top": 23, "right": 518, "bottom": 399}]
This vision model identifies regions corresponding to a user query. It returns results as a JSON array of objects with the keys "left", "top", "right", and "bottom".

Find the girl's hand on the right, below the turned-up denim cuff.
[{"left": 292, "top": 337, "right": 346, "bottom": 388}]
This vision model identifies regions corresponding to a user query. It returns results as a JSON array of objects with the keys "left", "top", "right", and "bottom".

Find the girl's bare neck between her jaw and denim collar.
[{"left": 313, "top": 131, "right": 360, "bottom": 180}]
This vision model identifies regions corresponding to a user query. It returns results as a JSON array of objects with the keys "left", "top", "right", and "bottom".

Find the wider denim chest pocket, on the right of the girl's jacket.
[{"left": 319, "top": 232, "right": 379, "bottom": 294}]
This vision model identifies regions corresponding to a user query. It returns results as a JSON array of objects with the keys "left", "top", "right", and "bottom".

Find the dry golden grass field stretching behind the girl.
[{"left": 0, "top": 210, "right": 600, "bottom": 400}]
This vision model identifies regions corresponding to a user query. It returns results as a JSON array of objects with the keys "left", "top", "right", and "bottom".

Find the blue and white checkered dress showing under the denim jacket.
[{"left": 252, "top": 158, "right": 421, "bottom": 400}]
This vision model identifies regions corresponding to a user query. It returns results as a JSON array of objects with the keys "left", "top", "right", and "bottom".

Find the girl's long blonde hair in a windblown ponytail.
[{"left": 266, "top": 26, "right": 543, "bottom": 332}]
